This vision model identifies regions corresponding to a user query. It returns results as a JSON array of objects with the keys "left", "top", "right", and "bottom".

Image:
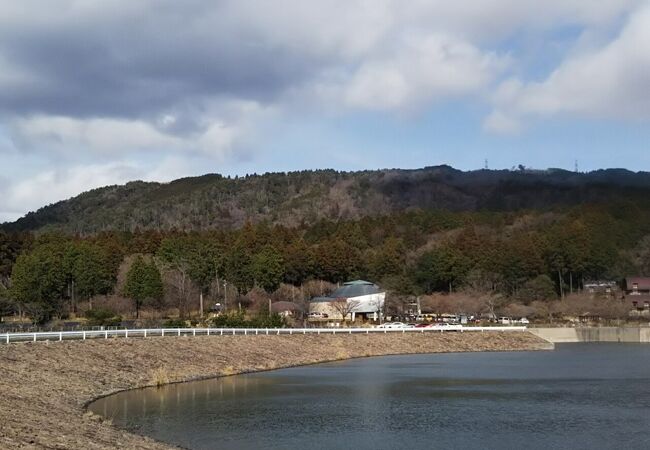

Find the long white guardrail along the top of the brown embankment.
[{"left": 0, "top": 326, "right": 526, "bottom": 344}]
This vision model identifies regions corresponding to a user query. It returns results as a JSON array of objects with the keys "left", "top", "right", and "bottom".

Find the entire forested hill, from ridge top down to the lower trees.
[{"left": 0, "top": 166, "right": 650, "bottom": 322}]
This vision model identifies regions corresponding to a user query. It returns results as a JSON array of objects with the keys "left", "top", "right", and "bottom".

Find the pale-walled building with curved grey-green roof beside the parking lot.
[{"left": 309, "top": 280, "right": 386, "bottom": 322}]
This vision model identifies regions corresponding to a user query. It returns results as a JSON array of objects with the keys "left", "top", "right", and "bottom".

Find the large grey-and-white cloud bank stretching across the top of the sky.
[{"left": 0, "top": 0, "right": 642, "bottom": 117}]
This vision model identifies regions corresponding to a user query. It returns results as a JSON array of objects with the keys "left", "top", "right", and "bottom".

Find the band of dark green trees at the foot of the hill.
[{"left": 0, "top": 203, "right": 650, "bottom": 323}]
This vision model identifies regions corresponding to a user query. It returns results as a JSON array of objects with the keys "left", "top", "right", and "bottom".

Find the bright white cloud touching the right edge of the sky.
[{"left": 485, "top": 3, "right": 650, "bottom": 128}]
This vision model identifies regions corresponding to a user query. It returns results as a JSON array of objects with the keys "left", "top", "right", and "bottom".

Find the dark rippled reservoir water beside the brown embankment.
[{"left": 90, "top": 344, "right": 650, "bottom": 450}]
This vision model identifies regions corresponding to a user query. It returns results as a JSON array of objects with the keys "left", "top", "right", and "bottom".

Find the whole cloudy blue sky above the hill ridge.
[{"left": 0, "top": 0, "right": 650, "bottom": 222}]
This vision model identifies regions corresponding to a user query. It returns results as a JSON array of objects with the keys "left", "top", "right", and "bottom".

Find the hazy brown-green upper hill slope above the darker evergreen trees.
[{"left": 1, "top": 166, "right": 650, "bottom": 234}]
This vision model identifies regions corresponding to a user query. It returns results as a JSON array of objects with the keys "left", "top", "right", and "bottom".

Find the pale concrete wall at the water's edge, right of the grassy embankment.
[{"left": 528, "top": 327, "right": 650, "bottom": 344}]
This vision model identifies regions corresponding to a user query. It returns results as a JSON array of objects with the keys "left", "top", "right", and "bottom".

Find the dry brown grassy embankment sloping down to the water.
[{"left": 0, "top": 332, "right": 552, "bottom": 449}]
